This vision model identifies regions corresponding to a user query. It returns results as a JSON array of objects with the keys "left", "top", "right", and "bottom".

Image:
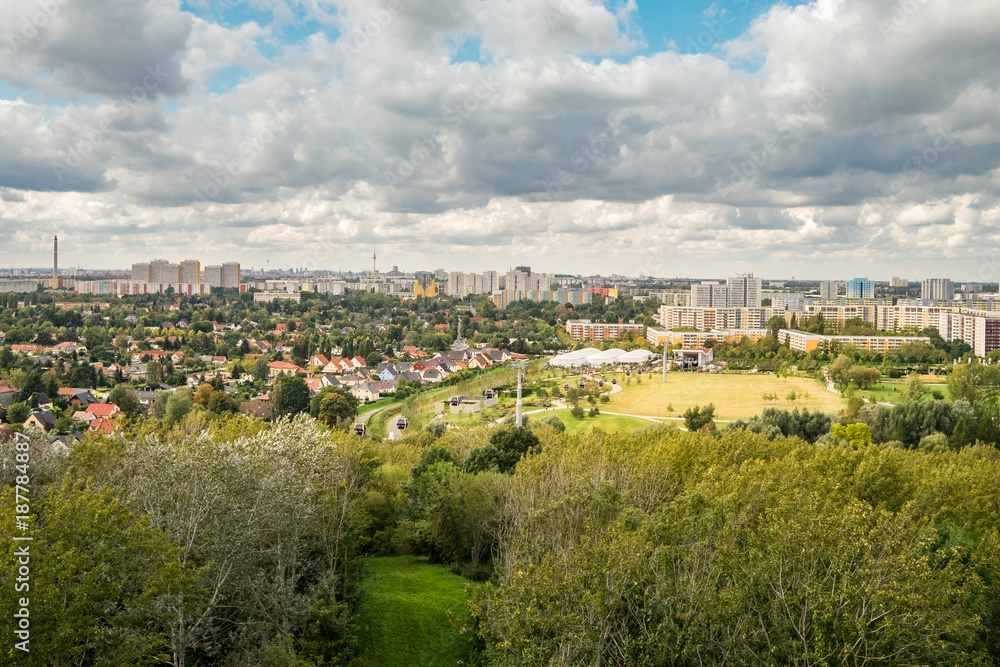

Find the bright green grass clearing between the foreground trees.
[{"left": 358, "top": 556, "right": 473, "bottom": 667}]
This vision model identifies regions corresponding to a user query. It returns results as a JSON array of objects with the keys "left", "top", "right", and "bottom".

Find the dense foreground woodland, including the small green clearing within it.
[{"left": 0, "top": 354, "right": 1000, "bottom": 667}]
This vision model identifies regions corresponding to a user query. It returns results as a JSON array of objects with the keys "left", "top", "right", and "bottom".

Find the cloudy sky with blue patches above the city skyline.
[{"left": 0, "top": 0, "right": 1000, "bottom": 281}]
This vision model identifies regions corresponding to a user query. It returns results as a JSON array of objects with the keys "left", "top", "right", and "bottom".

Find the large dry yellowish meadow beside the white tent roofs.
[{"left": 600, "top": 372, "right": 844, "bottom": 421}]
